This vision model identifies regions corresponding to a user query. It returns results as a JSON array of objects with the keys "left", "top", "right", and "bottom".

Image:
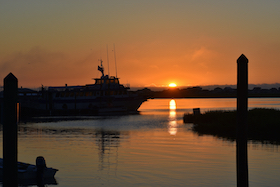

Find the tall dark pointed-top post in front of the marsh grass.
[{"left": 236, "top": 54, "right": 249, "bottom": 187}]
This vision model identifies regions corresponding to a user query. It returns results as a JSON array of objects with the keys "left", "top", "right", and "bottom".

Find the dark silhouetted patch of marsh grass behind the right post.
[{"left": 184, "top": 108, "right": 280, "bottom": 144}]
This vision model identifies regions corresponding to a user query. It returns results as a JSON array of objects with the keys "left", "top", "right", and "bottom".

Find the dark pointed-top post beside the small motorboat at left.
[{"left": 3, "top": 73, "right": 18, "bottom": 187}]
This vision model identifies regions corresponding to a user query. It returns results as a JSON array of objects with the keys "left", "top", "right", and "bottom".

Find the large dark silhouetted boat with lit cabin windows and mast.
[{"left": 19, "top": 60, "right": 146, "bottom": 116}]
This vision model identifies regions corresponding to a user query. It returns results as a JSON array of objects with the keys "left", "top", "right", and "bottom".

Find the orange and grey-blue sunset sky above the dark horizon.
[{"left": 0, "top": 0, "right": 280, "bottom": 87}]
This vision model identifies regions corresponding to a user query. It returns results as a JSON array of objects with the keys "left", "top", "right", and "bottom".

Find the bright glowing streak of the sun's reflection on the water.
[{"left": 168, "top": 99, "right": 178, "bottom": 135}]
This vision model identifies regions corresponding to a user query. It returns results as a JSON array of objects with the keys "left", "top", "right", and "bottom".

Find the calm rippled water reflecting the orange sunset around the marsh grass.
[{"left": 1, "top": 98, "right": 280, "bottom": 187}]
